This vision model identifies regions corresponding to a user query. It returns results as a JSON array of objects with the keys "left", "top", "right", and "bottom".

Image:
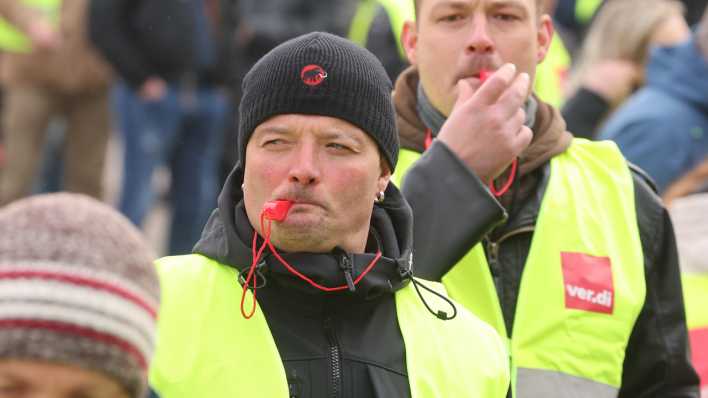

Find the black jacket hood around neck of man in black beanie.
[{"left": 194, "top": 165, "right": 413, "bottom": 299}]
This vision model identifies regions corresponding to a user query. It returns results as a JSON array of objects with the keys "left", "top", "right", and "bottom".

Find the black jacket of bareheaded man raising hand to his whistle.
[{"left": 402, "top": 136, "right": 698, "bottom": 398}]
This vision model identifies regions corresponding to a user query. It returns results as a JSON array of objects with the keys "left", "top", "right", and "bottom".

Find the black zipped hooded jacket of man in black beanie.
[{"left": 188, "top": 169, "right": 420, "bottom": 398}]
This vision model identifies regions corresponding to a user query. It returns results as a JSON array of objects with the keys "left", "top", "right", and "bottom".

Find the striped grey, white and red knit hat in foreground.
[{"left": 0, "top": 193, "right": 159, "bottom": 398}]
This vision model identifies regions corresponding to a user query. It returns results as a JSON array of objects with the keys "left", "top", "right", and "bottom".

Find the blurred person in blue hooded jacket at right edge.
[{"left": 600, "top": 6, "right": 708, "bottom": 192}]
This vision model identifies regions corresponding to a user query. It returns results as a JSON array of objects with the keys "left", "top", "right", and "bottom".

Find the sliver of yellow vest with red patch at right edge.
[{"left": 681, "top": 274, "right": 708, "bottom": 394}]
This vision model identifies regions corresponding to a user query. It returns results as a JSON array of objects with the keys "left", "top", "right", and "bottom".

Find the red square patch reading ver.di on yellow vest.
[{"left": 561, "top": 252, "right": 615, "bottom": 314}]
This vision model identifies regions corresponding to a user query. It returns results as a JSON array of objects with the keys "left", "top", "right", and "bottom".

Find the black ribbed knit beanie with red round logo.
[{"left": 238, "top": 32, "right": 398, "bottom": 171}]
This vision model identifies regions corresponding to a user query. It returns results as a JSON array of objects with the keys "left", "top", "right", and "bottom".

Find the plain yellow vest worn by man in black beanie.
[{"left": 150, "top": 255, "right": 509, "bottom": 398}]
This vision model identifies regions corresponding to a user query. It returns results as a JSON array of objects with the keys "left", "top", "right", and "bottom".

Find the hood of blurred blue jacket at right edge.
[{"left": 647, "top": 35, "right": 708, "bottom": 112}]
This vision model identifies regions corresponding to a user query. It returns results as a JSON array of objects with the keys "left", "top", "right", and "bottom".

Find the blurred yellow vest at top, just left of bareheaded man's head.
[{"left": 349, "top": 0, "right": 415, "bottom": 59}]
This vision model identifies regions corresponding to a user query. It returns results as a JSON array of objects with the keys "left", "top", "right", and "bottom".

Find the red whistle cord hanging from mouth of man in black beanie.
[{"left": 241, "top": 205, "right": 381, "bottom": 319}]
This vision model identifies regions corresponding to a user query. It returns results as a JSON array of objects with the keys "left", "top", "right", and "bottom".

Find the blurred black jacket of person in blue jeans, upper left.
[{"left": 89, "top": 0, "right": 236, "bottom": 87}]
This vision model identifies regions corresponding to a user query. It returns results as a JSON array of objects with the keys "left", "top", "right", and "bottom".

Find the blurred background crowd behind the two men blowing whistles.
[{"left": 0, "top": 0, "right": 708, "bottom": 254}]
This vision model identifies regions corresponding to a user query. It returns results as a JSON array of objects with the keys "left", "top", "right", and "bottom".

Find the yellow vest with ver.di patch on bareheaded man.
[{"left": 397, "top": 139, "right": 646, "bottom": 398}]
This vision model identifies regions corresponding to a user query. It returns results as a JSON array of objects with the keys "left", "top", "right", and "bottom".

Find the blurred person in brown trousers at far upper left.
[{"left": 0, "top": 0, "right": 110, "bottom": 208}]
